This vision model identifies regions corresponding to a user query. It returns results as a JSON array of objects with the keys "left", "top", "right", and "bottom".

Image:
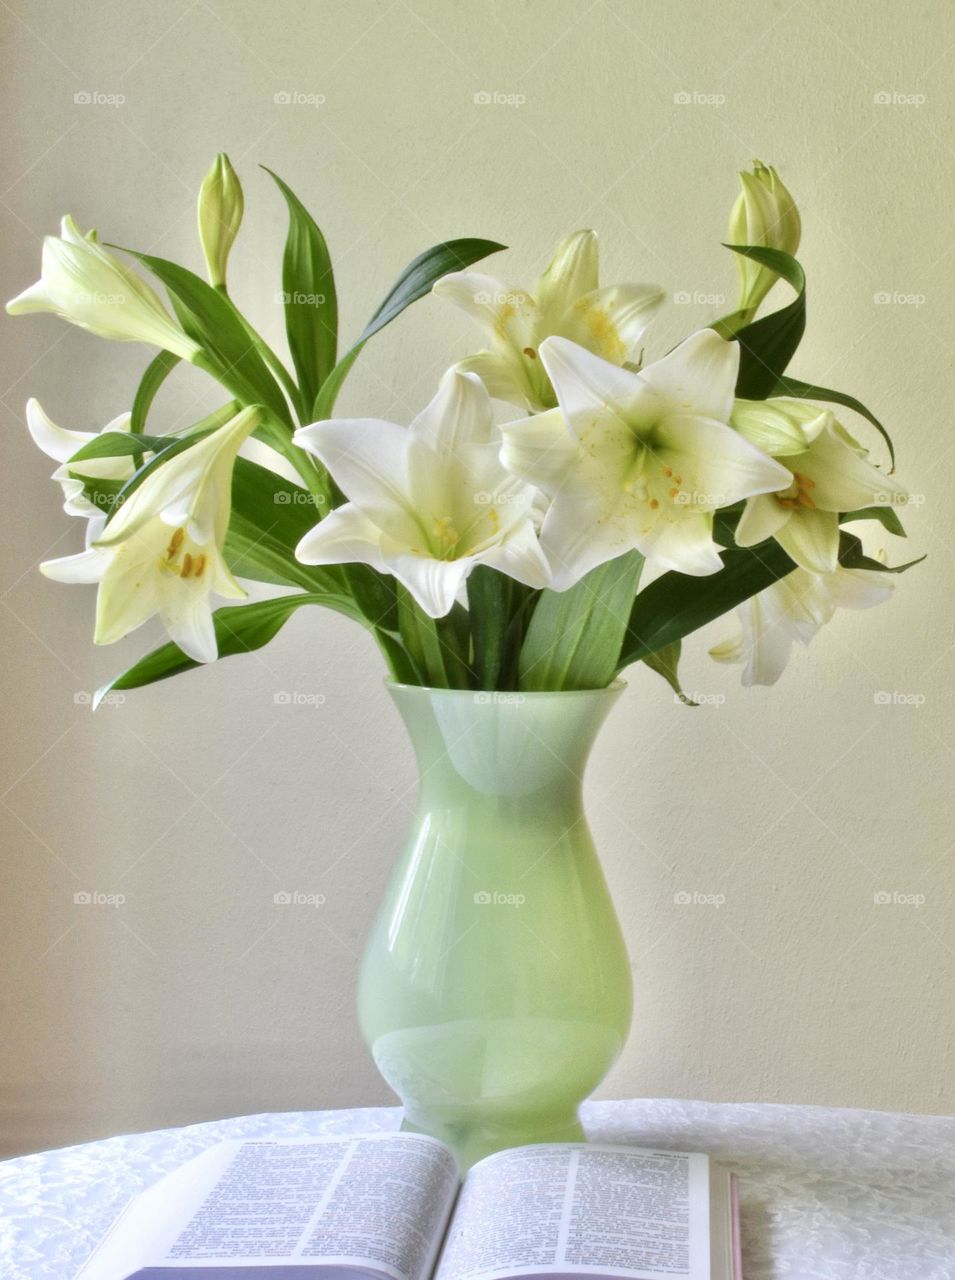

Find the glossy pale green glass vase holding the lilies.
[{"left": 358, "top": 684, "right": 632, "bottom": 1167}]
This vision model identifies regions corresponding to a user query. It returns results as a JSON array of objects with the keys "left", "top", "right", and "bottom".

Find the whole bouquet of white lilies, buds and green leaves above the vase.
[{"left": 8, "top": 155, "right": 908, "bottom": 696}]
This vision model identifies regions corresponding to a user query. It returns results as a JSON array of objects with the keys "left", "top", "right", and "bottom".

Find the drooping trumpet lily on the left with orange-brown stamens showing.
[{"left": 40, "top": 408, "right": 260, "bottom": 662}]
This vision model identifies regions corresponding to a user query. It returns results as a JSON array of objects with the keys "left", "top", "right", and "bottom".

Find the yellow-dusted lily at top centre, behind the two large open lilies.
[{"left": 431, "top": 230, "right": 663, "bottom": 412}]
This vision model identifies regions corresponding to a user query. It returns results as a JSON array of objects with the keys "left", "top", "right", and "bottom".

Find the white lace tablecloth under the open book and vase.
[{"left": 0, "top": 1100, "right": 955, "bottom": 1280}]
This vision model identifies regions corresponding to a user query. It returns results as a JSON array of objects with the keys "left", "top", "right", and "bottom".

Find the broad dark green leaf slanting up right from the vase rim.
[{"left": 617, "top": 540, "right": 796, "bottom": 671}]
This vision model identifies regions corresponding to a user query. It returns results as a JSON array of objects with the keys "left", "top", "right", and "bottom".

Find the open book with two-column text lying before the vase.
[{"left": 77, "top": 1133, "right": 739, "bottom": 1280}]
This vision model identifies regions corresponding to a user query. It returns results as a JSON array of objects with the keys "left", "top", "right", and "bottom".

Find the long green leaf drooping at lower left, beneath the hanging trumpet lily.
[{"left": 93, "top": 591, "right": 338, "bottom": 708}]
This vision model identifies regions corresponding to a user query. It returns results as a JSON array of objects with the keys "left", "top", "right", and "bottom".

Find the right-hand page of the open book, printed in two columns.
[{"left": 437, "top": 1143, "right": 710, "bottom": 1280}]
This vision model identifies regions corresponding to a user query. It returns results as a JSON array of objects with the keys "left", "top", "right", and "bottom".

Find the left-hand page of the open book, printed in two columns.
[{"left": 75, "top": 1134, "right": 458, "bottom": 1280}]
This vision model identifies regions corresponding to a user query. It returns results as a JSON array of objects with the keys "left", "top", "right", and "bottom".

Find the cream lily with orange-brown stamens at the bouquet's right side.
[{"left": 731, "top": 398, "right": 905, "bottom": 573}]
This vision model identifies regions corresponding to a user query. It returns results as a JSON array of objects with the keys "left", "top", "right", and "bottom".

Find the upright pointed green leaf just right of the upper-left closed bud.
[{"left": 262, "top": 165, "right": 338, "bottom": 407}]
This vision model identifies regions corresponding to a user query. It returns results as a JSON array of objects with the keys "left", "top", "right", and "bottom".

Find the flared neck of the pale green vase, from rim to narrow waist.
[{"left": 389, "top": 685, "right": 623, "bottom": 800}]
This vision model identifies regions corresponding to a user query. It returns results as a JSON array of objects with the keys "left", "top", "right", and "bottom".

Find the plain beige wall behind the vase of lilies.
[{"left": 0, "top": 0, "right": 955, "bottom": 1152}]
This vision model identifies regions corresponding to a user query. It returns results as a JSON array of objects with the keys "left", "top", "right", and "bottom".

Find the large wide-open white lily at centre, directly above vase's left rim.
[{"left": 294, "top": 369, "right": 548, "bottom": 618}]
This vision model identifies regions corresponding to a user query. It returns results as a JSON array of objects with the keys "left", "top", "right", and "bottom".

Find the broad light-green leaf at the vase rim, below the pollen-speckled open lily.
[{"left": 518, "top": 552, "right": 644, "bottom": 691}]
